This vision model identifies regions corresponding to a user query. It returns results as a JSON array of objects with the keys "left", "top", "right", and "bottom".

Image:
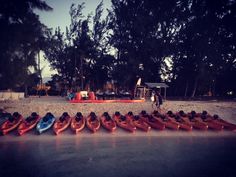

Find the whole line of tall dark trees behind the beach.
[{"left": 0, "top": 0, "right": 236, "bottom": 97}]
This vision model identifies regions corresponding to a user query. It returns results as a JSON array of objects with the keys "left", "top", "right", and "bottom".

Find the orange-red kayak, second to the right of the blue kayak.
[{"left": 70, "top": 112, "right": 85, "bottom": 134}]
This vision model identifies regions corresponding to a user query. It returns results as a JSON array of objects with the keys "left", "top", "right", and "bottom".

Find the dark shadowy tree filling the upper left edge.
[{"left": 0, "top": 0, "right": 51, "bottom": 95}]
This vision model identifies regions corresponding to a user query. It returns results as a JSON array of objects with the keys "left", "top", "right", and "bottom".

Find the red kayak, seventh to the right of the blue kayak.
[{"left": 139, "top": 111, "right": 165, "bottom": 130}]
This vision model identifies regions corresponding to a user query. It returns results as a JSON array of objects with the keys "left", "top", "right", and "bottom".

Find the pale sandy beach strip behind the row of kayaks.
[{"left": 0, "top": 96, "right": 236, "bottom": 123}]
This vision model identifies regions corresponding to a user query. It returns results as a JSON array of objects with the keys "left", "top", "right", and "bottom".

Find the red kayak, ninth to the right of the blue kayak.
[{"left": 166, "top": 111, "right": 193, "bottom": 131}]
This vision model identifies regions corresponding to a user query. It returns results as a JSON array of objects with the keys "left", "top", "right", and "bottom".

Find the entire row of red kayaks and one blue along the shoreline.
[{"left": 0, "top": 111, "right": 236, "bottom": 135}]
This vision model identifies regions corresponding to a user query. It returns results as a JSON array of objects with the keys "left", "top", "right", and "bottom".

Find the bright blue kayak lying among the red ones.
[{"left": 36, "top": 112, "right": 56, "bottom": 134}]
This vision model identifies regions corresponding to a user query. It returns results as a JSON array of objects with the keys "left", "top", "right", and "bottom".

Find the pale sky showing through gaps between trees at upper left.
[{"left": 35, "top": 0, "right": 111, "bottom": 77}]
